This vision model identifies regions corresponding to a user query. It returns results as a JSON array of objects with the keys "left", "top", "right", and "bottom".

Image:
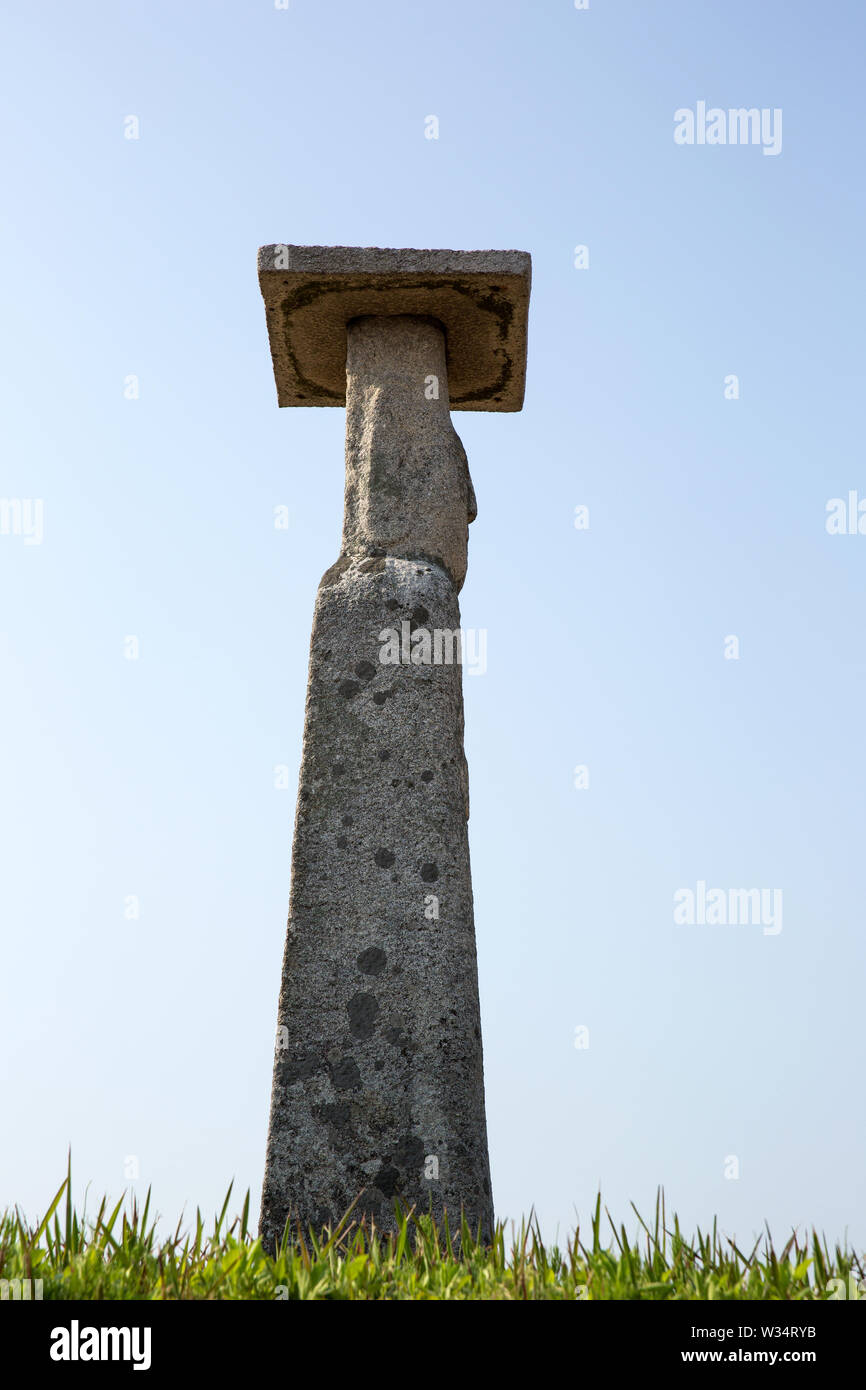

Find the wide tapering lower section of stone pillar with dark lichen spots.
[{"left": 260, "top": 556, "right": 493, "bottom": 1247}]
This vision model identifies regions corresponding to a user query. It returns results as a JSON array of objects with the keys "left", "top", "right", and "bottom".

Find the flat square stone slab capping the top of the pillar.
[{"left": 259, "top": 245, "right": 532, "bottom": 410}]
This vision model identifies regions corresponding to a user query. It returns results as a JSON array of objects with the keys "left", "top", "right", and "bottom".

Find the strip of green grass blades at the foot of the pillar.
[{"left": 0, "top": 1175, "right": 866, "bottom": 1301}]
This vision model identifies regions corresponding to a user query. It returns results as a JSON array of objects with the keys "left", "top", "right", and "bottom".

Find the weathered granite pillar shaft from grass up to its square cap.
[{"left": 254, "top": 247, "right": 528, "bottom": 1247}]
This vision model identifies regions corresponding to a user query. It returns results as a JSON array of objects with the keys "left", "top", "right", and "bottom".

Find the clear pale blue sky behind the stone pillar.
[{"left": 0, "top": 0, "right": 866, "bottom": 1245}]
